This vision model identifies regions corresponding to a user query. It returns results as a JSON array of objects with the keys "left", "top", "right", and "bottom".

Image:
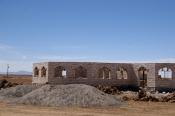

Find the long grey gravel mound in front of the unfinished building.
[{"left": 0, "top": 84, "right": 121, "bottom": 107}]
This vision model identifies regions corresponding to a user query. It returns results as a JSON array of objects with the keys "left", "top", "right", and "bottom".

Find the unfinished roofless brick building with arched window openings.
[{"left": 32, "top": 62, "right": 175, "bottom": 90}]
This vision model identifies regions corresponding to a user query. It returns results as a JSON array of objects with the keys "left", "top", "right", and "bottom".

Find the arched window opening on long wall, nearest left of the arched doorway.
[{"left": 117, "top": 68, "right": 128, "bottom": 79}]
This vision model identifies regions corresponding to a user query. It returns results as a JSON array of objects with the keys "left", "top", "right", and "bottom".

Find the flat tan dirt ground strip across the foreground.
[{"left": 0, "top": 101, "right": 175, "bottom": 116}]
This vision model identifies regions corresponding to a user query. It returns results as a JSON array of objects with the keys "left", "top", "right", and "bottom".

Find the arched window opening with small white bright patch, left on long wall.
[{"left": 55, "top": 66, "right": 67, "bottom": 77}]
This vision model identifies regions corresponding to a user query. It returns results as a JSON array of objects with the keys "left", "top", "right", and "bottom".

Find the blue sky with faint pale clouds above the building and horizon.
[{"left": 0, "top": 0, "right": 175, "bottom": 72}]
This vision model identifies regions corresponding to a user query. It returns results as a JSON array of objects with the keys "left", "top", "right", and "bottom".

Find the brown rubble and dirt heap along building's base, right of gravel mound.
[{"left": 96, "top": 85, "right": 175, "bottom": 102}]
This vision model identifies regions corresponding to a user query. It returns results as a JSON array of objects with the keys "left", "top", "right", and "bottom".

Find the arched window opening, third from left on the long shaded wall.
[{"left": 98, "top": 67, "right": 111, "bottom": 79}]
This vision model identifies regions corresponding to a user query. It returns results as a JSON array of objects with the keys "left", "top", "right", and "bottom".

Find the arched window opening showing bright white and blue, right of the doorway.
[{"left": 158, "top": 67, "right": 172, "bottom": 79}]
